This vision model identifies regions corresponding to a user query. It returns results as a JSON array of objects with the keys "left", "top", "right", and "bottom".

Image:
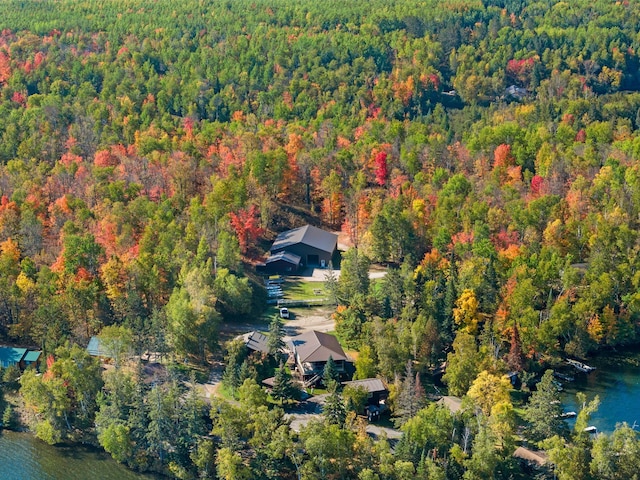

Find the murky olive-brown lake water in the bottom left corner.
[{"left": 0, "top": 430, "right": 159, "bottom": 480}]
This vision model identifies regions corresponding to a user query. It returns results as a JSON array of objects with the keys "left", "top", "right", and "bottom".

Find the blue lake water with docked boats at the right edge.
[{"left": 561, "top": 351, "right": 640, "bottom": 433}]
